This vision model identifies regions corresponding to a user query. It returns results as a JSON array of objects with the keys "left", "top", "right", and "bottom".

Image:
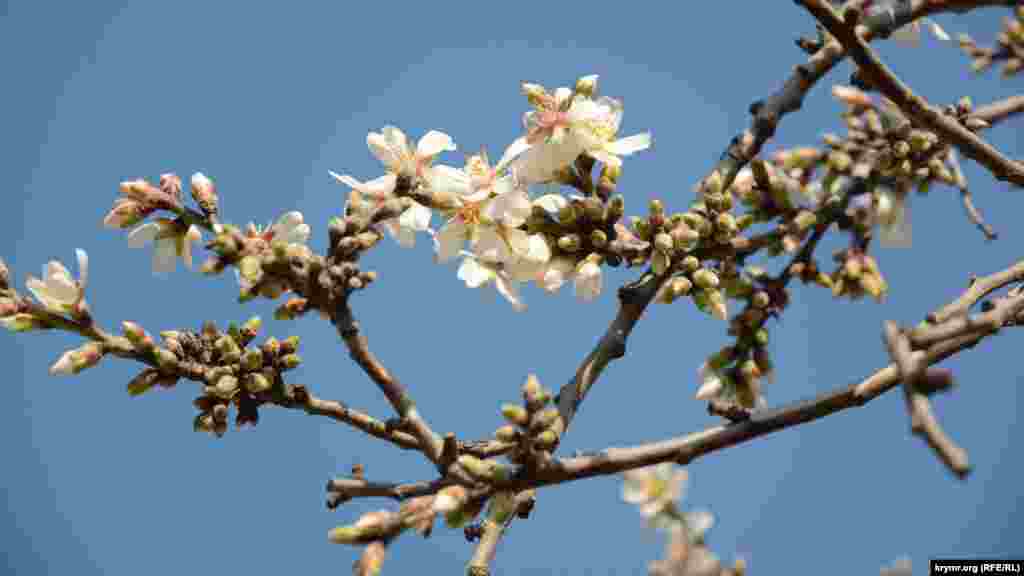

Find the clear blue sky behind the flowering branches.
[{"left": 0, "top": 0, "right": 1024, "bottom": 574}]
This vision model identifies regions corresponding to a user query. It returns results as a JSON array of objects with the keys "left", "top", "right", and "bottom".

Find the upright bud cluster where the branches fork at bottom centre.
[{"left": 491, "top": 374, "right": 565, "bottom": 461}]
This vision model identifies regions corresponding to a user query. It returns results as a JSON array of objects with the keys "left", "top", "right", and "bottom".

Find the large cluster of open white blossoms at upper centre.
[{"left": 331, "top": 76, "right": 651, "bottom": 311}]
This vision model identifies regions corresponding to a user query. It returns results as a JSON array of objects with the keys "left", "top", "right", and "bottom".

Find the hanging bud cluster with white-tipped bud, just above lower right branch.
[{"left": 696, "top": 338, "right": 774, "bottom": 415}]
